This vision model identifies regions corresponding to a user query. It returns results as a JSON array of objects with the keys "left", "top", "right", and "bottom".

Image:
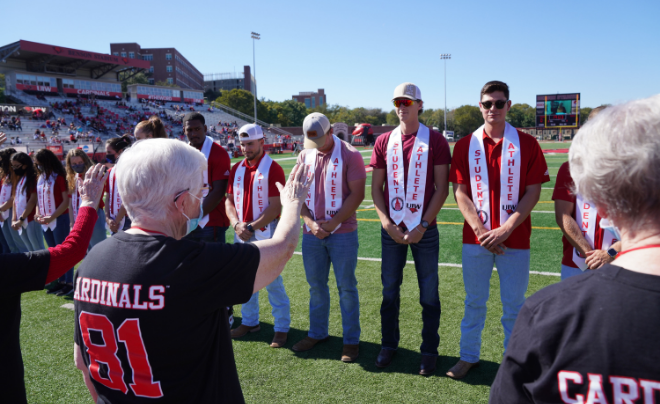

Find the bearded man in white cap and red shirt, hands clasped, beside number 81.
[{"left": 225, "top": 124, "right": 291, "bottom": 348}]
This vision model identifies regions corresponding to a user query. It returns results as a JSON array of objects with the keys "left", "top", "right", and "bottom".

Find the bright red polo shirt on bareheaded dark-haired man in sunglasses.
[{"left": 449, "top": 131, "right": 550, "bottom": 250}]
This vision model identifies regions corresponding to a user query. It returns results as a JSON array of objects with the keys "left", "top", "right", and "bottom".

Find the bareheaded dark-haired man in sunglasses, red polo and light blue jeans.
[{"left": 447, "top": 81, "right": 550, "bottom": 379}]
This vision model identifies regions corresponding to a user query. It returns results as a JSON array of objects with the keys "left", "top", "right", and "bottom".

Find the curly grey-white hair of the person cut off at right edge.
[{"left": 568, "top": 95, "right": 660, "bottom": 232}]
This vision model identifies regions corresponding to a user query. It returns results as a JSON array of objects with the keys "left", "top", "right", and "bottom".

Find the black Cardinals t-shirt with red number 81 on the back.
[{"left": 74, "top": 231, "right": 260, "bottom": 404}]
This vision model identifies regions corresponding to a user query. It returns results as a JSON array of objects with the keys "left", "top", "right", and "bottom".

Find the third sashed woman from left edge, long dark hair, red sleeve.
[{"left": 34, "top": 149, "right": 73, "bottom": 296}]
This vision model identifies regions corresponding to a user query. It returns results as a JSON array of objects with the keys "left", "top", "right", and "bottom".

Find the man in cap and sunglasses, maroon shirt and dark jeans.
[{"left": 370, "top": 83, "right": 451, "bottom": 376}]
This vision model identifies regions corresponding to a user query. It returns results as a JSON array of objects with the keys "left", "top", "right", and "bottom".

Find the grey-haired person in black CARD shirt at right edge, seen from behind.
[{"left": 490, "top": 95, "right": 660, "bottom": 403}]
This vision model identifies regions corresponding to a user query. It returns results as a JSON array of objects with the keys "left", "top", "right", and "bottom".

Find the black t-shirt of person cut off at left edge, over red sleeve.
[{"left": 0, "top": 250, "right": 50, "bottom": 403}]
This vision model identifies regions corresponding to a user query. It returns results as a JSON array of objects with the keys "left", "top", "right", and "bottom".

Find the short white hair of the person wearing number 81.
[{"left": 115, "top": 139, "right": 207, "bottom": 222}]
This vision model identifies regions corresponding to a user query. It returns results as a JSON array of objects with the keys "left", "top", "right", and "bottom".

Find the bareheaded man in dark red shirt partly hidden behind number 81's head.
[{"left": 183, "top": 112, "right": 231, "bottom": 243}]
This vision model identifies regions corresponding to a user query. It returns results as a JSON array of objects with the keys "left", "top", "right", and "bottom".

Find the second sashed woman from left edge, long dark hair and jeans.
[{"left": 11, "top": 152, "right": 44, "bottom": 251}]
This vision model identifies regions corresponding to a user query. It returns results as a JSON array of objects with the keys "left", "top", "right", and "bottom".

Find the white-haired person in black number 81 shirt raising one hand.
[{"left": 74, "top": 139, "right": 309, "bottom": 403}]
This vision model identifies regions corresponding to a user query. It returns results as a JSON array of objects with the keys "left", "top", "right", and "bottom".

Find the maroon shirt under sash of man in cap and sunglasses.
[{"left": 369, "top": 128, "right": 451, "bottom": 225}]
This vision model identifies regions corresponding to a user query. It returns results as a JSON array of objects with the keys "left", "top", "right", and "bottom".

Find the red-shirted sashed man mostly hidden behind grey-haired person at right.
[{"left": 552, "top": 107, "right": 621, "bottom": 280}]
